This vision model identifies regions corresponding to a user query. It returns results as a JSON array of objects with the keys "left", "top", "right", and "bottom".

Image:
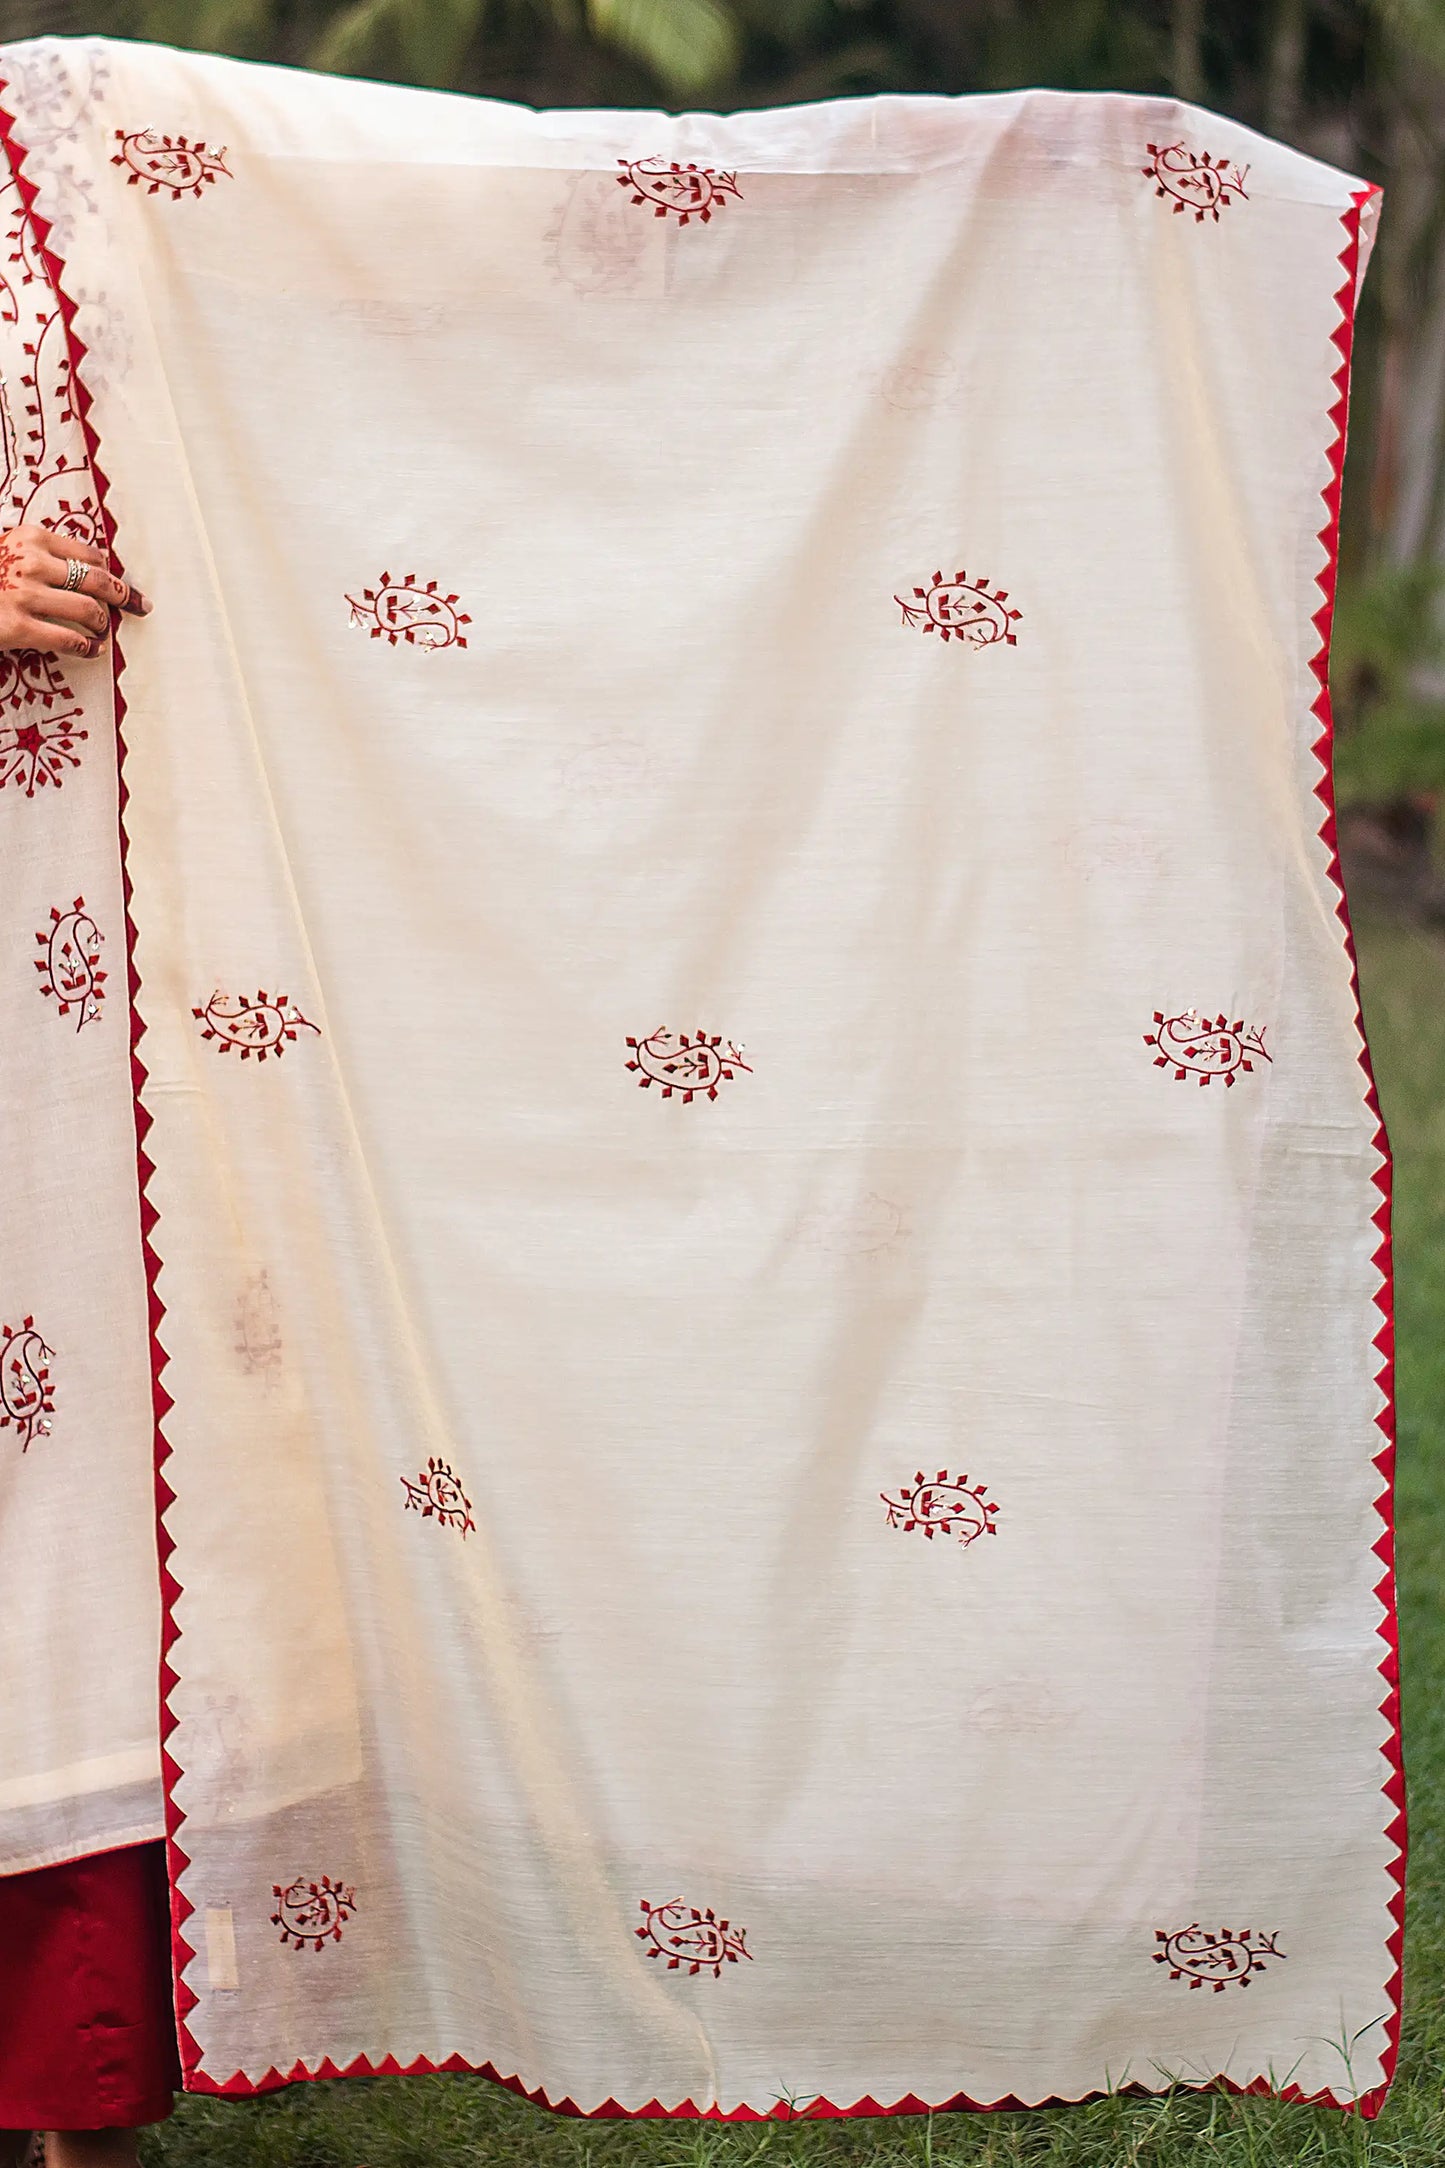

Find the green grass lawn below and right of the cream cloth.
[{"left": 143, "top": 924, "right": 1445, "bottom": 2168}]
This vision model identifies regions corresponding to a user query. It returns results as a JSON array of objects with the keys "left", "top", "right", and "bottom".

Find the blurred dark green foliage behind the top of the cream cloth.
[{"left": 0, "top": 0, "right": 1445, "bottom": 893}]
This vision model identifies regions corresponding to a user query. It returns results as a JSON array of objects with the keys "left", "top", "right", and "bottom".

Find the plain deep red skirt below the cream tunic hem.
[{"left": 0, "top": 1843, "right": 180, "bottom": 2131}]
